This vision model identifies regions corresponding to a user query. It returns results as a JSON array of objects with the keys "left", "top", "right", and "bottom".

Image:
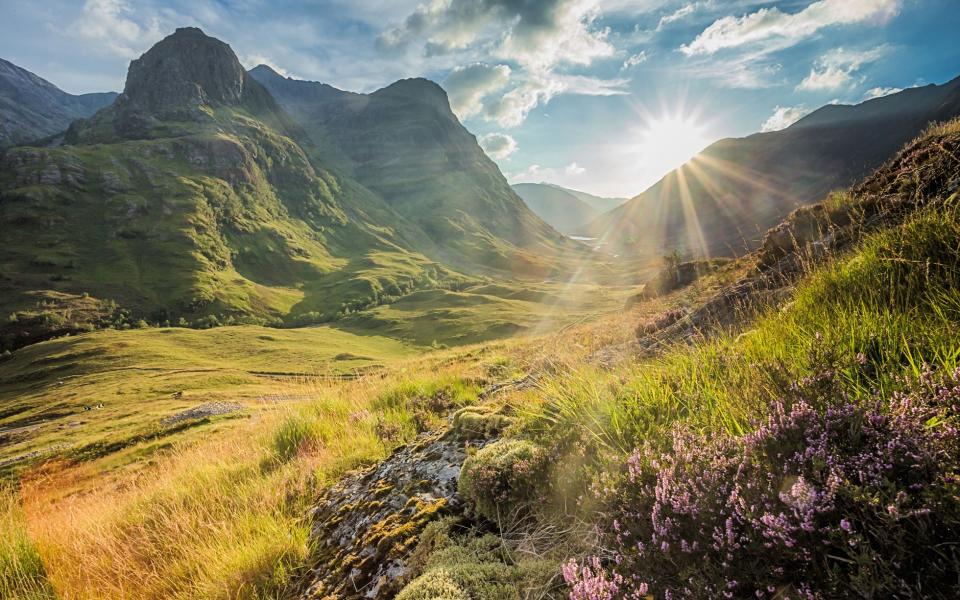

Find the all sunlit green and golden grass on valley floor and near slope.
[{"left": 0, "top": 122, "right": 960, "bottom": 599}]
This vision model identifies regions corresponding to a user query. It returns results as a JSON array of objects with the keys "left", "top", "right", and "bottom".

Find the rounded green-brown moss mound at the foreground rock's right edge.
[{"left": 459, "top": 439, "right": 547, "bottom": 523}]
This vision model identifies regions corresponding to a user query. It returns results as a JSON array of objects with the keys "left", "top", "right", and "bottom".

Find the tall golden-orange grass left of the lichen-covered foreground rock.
[{"left": 14, "top": 381, "right": 404, "bottom": 599}]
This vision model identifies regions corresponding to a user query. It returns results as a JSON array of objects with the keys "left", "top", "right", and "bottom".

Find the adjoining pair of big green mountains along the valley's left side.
[{"left": 0, "top": 28, "right": 568, "bottom": 348}]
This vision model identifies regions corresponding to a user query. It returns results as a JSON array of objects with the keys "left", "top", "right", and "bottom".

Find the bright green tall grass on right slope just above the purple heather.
[{"left": 523, "top": 205, "right": 960, "bottom": 454}]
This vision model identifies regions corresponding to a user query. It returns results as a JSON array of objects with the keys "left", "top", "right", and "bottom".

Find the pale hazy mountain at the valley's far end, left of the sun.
[{"left": 513, "top": 183, "right": 627, "bottom": 234}]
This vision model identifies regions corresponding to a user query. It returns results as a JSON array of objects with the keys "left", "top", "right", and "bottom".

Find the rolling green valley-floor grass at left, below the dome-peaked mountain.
[{"left": 0, "top": 326, "right": 417, "bottom": 478}]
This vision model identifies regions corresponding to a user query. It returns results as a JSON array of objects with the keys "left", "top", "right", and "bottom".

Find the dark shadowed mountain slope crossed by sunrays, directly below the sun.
[{"left": 584, "top": 78, "right": 960, "bottom": 256}]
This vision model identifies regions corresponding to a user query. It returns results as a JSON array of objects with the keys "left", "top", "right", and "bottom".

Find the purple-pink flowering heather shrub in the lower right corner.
[{"left": 563, "top": 370, "right": 960, "bottom": 600}]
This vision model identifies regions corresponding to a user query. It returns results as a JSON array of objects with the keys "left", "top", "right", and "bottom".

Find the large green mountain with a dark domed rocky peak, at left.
[{"left": 0, "top": 28, "right": 468, "bottom": 348}]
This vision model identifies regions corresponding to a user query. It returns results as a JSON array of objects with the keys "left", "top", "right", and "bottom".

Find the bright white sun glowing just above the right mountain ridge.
[{"left": 637, "top": 115, "right": 710, "bottom": 177}]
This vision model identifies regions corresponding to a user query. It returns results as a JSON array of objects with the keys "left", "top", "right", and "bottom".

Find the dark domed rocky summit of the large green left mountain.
[{"left": 123, "top": 27, "right": 249, "bottom": 114}]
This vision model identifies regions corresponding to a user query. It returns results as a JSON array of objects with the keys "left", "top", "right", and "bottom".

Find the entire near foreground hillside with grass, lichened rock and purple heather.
[{"left": 0, "top": 104, "right": 960, "bottom": 600}]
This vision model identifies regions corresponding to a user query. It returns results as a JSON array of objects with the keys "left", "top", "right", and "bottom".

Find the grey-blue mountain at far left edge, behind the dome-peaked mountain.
[{"left": 0, "top": 58, "right": 117, "bottom": 148}]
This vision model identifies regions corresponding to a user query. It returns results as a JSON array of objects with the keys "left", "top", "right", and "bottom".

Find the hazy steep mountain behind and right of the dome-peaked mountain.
[{"left": 250, "top": 65, "right": 567, "bottom": 273}]
